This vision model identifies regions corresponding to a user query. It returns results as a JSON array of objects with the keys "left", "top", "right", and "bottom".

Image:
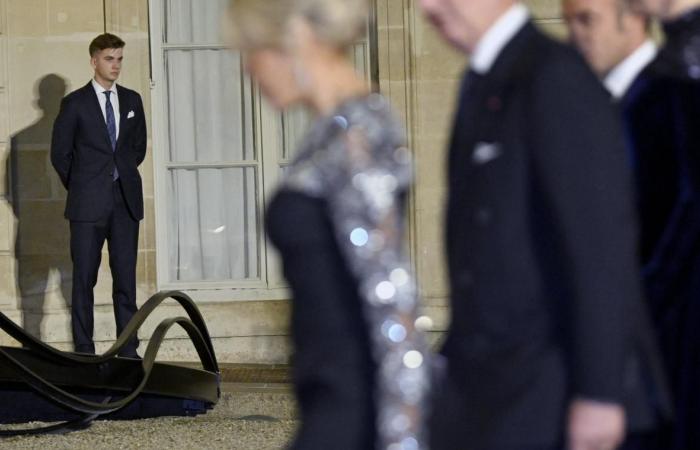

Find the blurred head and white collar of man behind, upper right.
[{"left": 562, "top": 0, "right": 657, "bottom": 100}]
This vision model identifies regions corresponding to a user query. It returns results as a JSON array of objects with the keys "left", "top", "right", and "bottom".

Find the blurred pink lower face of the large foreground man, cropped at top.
[{"left": 420, "top": 0, "right": 517, "bottom": 53}]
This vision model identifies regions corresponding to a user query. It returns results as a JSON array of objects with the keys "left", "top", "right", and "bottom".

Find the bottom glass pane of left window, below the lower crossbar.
[{"left": 168, "top": 167, "right": 260, "bottom": 281}]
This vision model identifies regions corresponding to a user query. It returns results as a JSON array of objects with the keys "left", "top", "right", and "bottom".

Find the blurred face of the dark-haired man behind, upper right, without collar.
[{"left": 563, "top": 0, "right": 649, "bottom": 76}]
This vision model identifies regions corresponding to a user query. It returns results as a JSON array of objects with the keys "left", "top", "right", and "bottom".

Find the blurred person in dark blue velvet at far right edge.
[{"left": 627, "top": 0, "right": 700, "bottom": 450}]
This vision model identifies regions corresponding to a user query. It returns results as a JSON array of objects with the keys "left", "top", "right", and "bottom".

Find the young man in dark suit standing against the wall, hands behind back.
[{"left": 51, "top": 34, "right": 146, "bottom": 357}]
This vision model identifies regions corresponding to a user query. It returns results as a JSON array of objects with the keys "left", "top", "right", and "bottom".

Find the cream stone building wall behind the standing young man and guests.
[{"left": 0, "top": 0, "right": 561, "bottom": 363}]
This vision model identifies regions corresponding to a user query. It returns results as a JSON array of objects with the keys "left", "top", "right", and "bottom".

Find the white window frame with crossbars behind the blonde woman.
[{"left": 149, "top": 0, "right": 376, "bottom": 302}]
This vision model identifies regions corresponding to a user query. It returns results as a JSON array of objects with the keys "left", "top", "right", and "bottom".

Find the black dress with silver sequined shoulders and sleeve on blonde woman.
[{"left": 267, "top": 95, "right": 429, "bottom": 450}]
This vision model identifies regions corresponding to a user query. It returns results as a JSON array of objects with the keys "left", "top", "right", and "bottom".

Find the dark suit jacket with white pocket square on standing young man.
[{"left": 51, "top": 83, "right": 146, "bottom": 221}]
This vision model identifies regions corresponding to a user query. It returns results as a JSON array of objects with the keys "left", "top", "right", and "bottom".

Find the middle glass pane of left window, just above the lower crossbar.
[{"left": 166, "top": 50, "right": 255, "bottom": 162}]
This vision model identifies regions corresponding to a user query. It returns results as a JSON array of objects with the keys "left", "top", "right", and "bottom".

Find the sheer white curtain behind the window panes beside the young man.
[{"left": 164, "top": 0, "right": 260, "bottom": 281}]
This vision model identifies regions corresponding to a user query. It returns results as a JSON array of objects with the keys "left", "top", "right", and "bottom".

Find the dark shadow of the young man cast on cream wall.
[{"left": 6, "top": 74, "right": 72, "bottom": 340}]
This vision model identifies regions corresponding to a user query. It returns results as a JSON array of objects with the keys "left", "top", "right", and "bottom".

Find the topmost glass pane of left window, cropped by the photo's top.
[{"left": 163, "top": 0, "right": 228, "bottom": 44}]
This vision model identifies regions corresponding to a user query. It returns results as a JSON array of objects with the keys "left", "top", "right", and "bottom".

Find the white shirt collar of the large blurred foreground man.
[{"left": 470, "top": 2, "right": 530, "bottom": 75}]
